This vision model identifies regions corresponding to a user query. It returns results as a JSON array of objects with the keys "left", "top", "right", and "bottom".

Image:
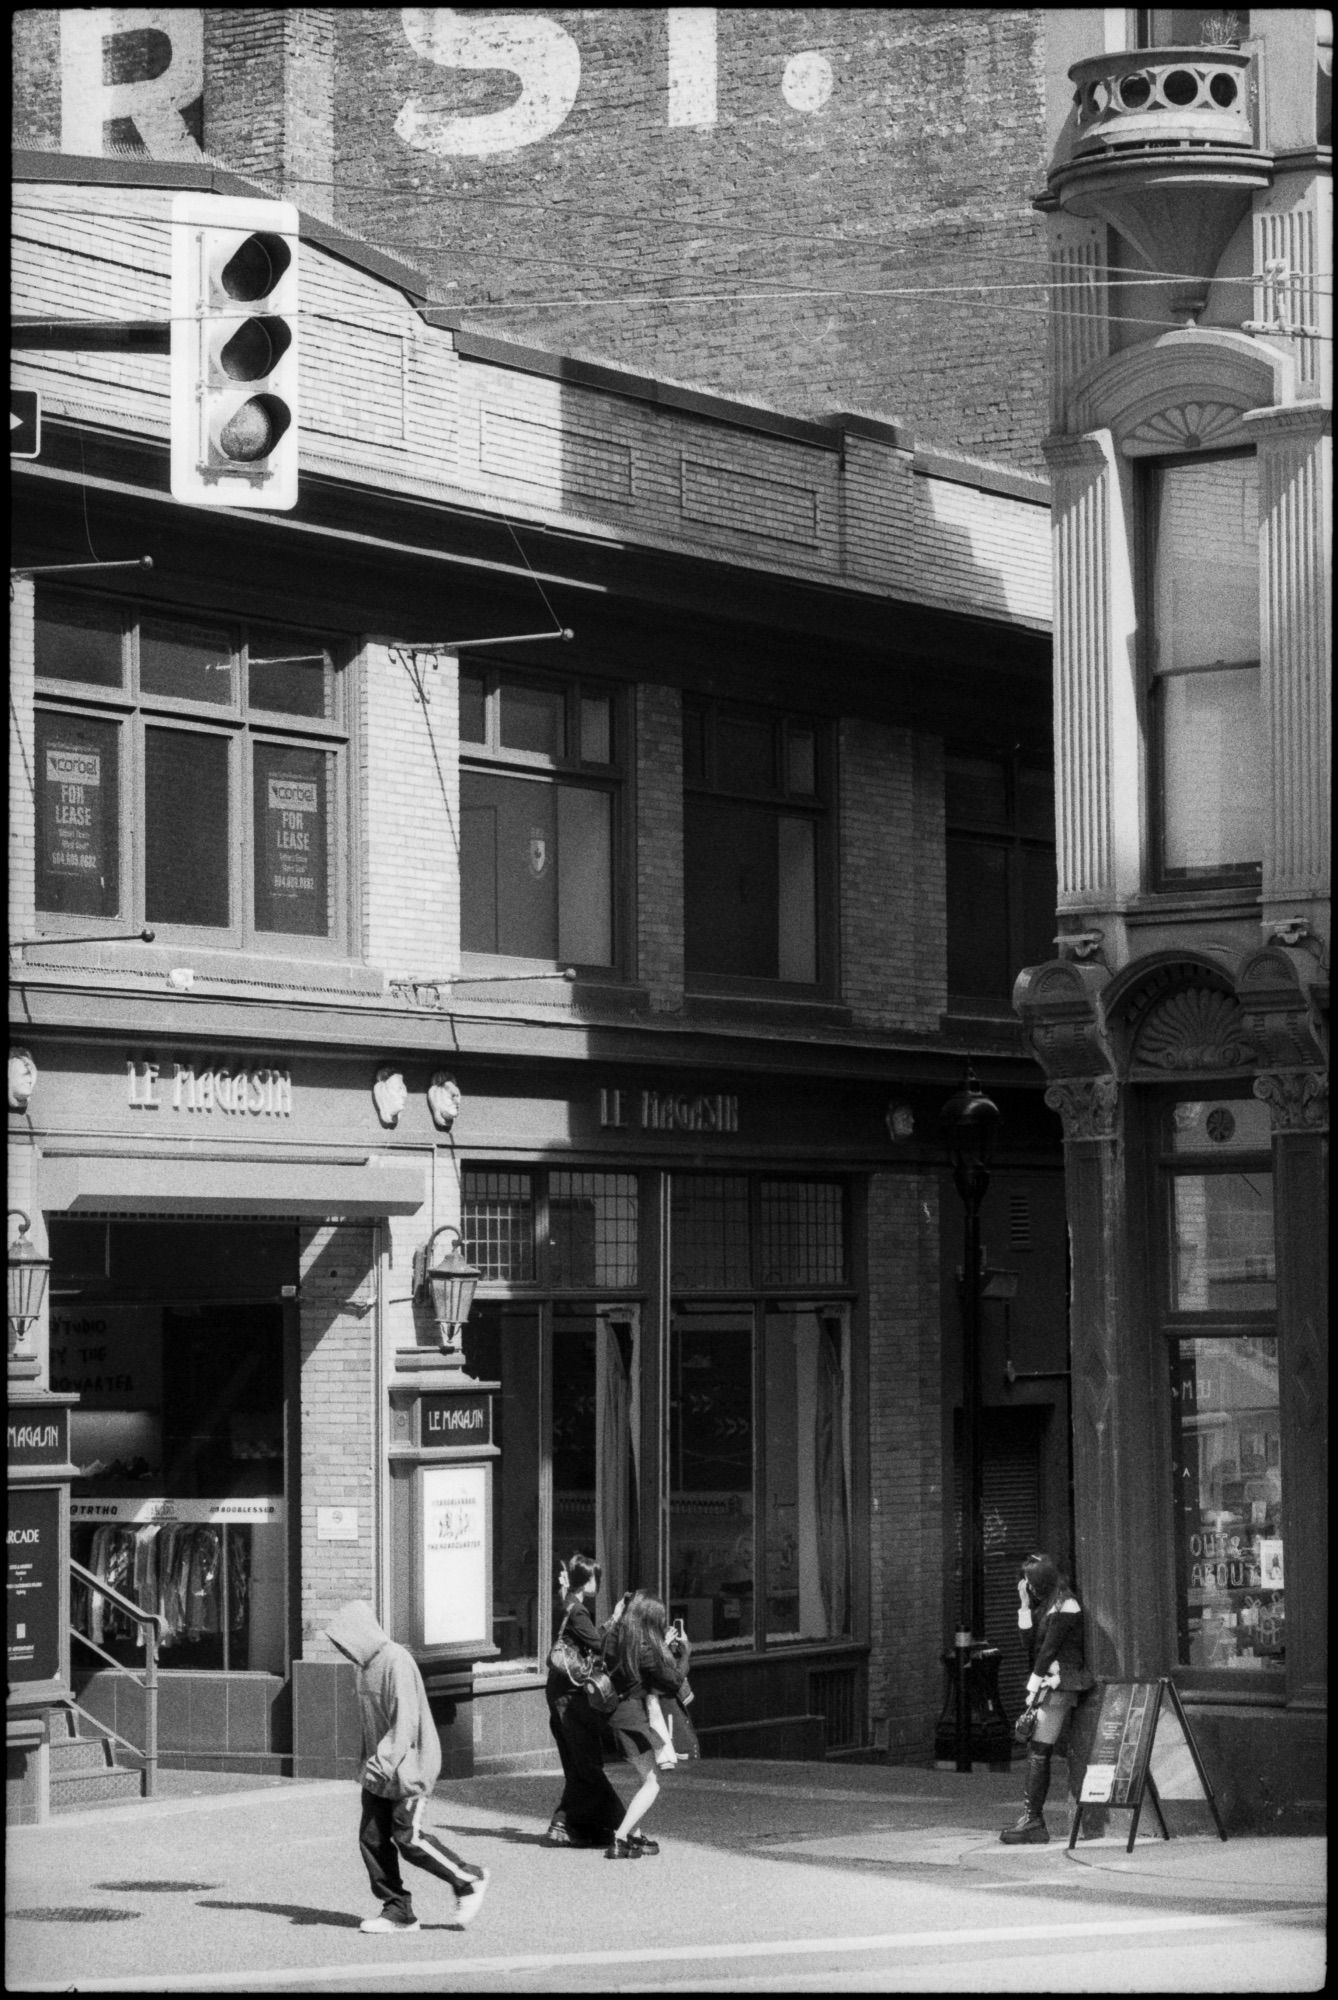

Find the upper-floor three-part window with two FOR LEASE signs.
[{"left": 36, "top": 590, "right": 348, "bottom": 952}]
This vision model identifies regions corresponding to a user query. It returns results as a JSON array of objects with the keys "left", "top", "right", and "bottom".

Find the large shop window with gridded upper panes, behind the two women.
[{"left": 462, "top": 1166, "right": 852, "bottom": 1662}]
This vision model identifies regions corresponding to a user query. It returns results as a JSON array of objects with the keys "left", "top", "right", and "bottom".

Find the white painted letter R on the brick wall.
[{"left": 60, "top": 6, "right": 204, "bottom": 160}]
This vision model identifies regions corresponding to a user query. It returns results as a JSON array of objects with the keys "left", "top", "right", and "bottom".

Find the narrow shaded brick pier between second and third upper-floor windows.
[{"left": 636, "top": 686, "right": 684, "bottom": 1014}]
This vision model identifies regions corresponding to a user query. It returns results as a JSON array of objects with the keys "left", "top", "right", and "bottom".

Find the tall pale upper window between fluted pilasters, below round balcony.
[{"left": 1144, "top": 452, "right": 1266, "bottom": 886}]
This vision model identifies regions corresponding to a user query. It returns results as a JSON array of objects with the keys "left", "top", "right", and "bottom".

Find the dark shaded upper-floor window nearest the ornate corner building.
[{"left": 944, "top": 754, "right": 1058, "bottom": 1010}]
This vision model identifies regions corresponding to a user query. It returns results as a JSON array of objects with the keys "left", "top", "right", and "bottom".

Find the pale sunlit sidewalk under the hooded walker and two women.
[{"left": 6, "top": 1760, "right": 1326, "bottom": 1992}]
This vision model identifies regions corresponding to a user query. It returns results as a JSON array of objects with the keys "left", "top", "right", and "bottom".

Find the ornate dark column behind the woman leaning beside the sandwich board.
[{"left": 1046, "top": 1074, "right": 1166, "bottom": 1678}]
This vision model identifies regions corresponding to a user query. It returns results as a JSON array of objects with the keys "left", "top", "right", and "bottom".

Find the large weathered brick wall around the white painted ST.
[{"left": 328, "top": 8, "right": 1046, "bottom": 464}]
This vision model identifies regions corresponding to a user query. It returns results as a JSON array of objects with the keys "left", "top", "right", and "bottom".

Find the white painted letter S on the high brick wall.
[{"left": 394, "top": 6, "right": 580, "bottom": 156}]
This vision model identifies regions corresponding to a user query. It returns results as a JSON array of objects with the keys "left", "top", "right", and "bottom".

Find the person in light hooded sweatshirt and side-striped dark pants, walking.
[{"left": 326, "top": 1598, "right": 488, "bottom": 1934}]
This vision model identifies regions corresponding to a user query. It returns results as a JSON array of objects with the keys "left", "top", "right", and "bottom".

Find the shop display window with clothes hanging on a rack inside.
[{"left": 48, "top": 1216, "right": 298, "bottom": 1674}]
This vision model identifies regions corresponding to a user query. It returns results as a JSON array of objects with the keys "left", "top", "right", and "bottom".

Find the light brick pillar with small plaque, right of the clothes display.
[{"left": 300, "top": 1224, "right": 380, "bottom": 1658}]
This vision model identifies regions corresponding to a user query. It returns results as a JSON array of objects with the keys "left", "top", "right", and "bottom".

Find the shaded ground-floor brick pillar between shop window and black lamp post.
[{"left": 868, "top": 1174, "right": 944, "bottom": 1760}]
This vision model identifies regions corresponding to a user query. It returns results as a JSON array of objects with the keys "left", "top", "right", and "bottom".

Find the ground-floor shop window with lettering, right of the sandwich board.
[{"left": 1172, "top": 1336, "right": 1286, "bottom": 1672}]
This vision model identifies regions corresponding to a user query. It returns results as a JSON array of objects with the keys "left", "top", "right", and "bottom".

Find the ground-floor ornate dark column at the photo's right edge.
[{"left": 1254, "top": 1068, "right": 1328, "bottom": 1708}]
